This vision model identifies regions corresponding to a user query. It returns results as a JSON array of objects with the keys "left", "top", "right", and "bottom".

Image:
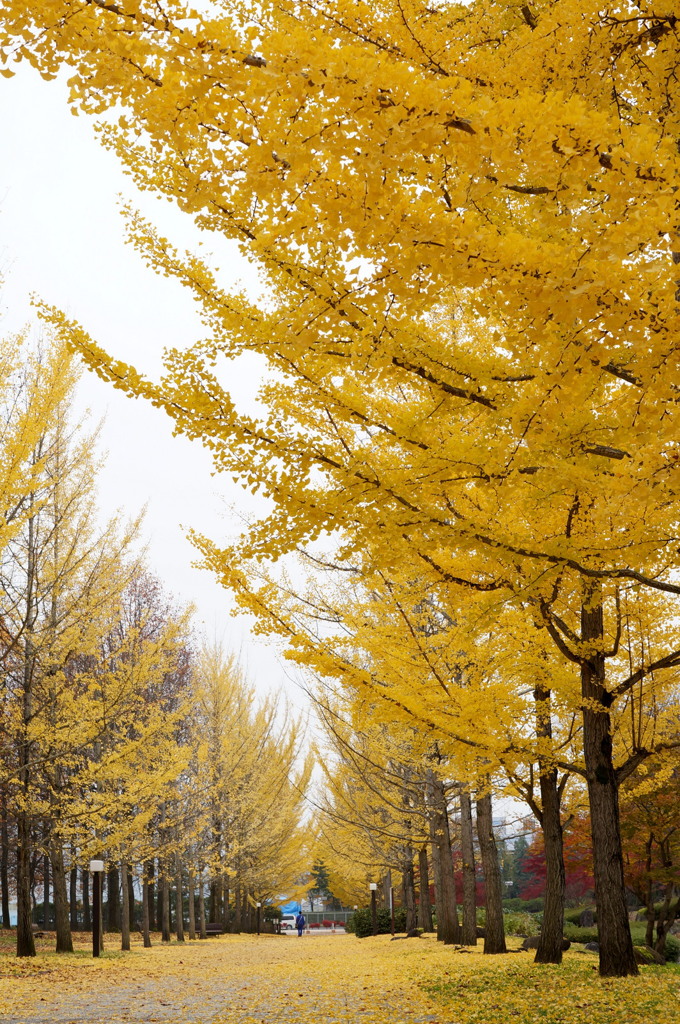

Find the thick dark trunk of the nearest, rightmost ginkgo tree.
[{"left": 581, "top": 584, "right": 639, "bottom": 978}]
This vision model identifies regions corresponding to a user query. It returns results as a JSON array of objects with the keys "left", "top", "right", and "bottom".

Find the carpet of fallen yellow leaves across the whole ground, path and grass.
[{"left": 0, "top": 935, "right": 680, "bottom": 1024}]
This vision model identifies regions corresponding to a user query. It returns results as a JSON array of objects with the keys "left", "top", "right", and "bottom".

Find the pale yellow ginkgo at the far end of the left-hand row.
[{"left": 190, "top": 644, "right": 313, "bottom": 931}]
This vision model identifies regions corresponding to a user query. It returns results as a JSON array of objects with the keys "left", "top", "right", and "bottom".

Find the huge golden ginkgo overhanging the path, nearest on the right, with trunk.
[{"left": 0, "top": 0, "right": 680, "bottom": 975}]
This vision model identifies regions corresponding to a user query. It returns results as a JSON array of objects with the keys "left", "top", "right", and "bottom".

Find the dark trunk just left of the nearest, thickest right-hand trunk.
[{"left": 534, "top": 686, "right": 565, "bottom": 964}]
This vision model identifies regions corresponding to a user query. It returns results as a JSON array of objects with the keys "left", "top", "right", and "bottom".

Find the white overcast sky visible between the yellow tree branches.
[{"left": 0, "top": 67, "right": 300, "bottom": 703}]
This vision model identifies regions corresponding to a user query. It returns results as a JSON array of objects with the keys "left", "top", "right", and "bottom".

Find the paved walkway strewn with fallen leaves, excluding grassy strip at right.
[{"left": 0, "top": 935, "right": 440, "bottom": 1024}]
